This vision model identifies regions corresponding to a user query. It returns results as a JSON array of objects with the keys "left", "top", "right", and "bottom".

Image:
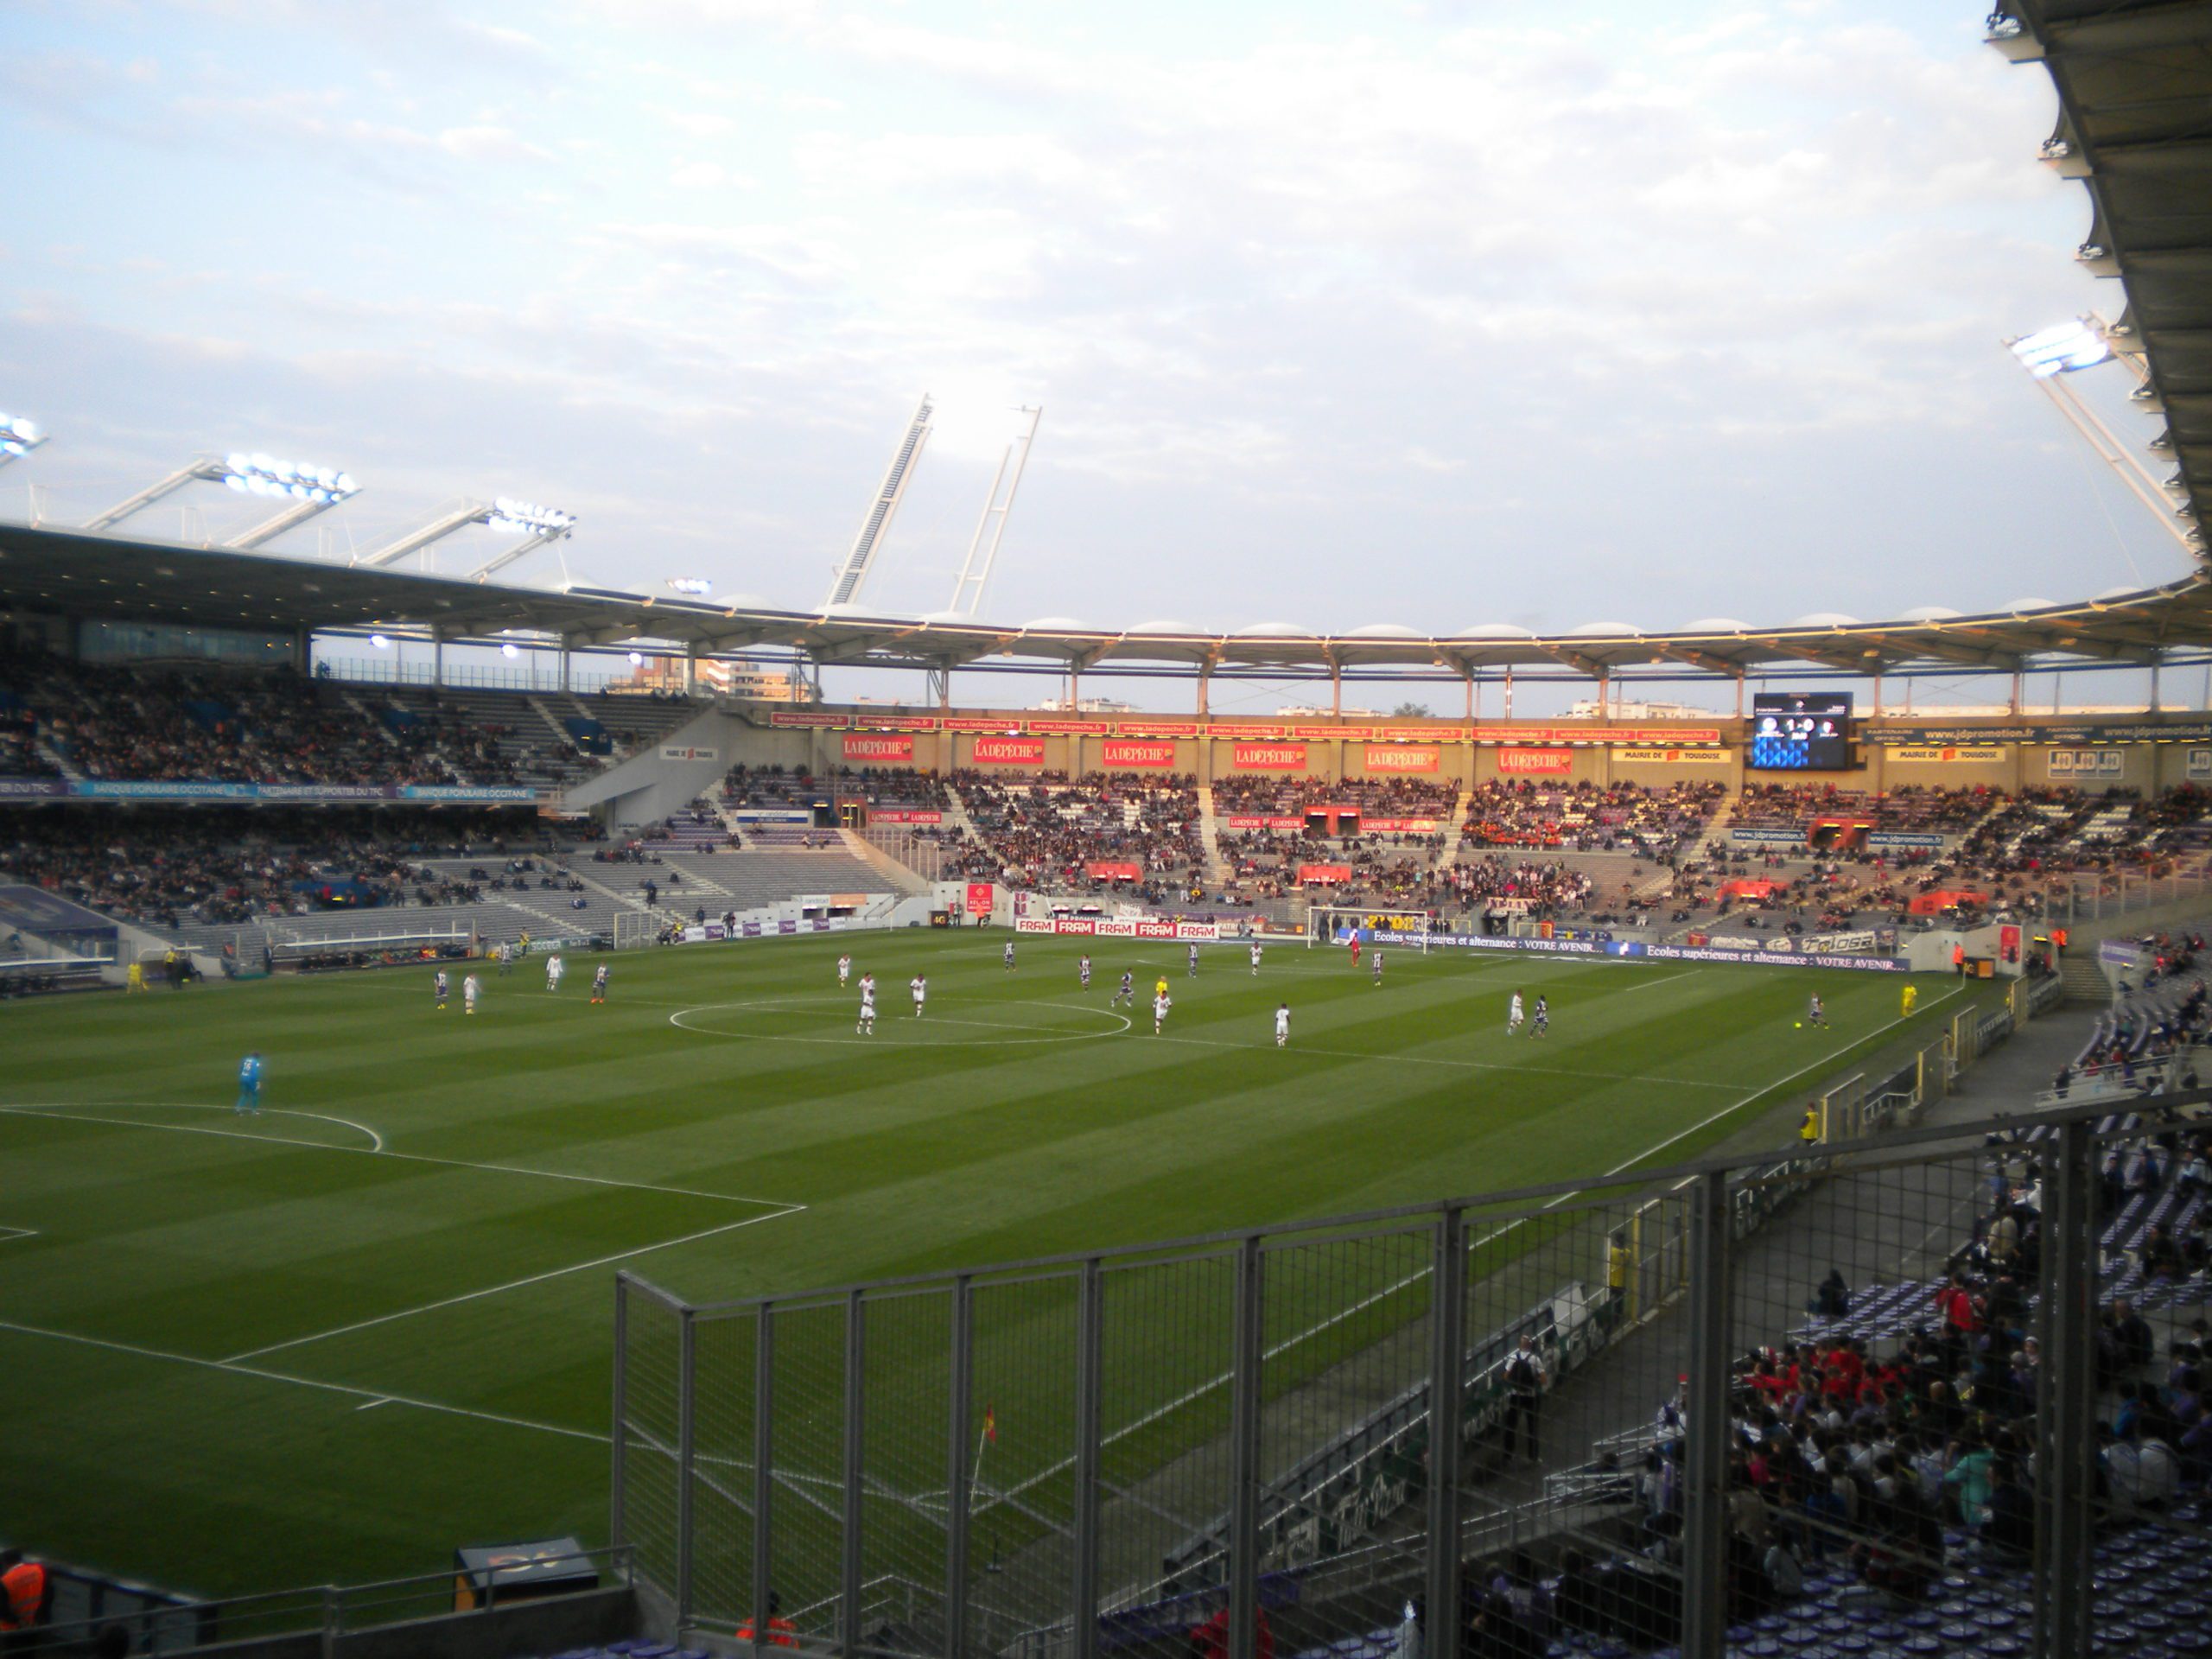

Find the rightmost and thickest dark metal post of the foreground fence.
[{"left": 2035, "top": 1122, "right": 2099, "bottom": 1659}]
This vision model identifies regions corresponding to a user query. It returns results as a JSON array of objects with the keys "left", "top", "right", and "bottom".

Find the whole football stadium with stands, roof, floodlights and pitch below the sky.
[{"left": 0, "top": 0, "right": 2212, "bottom": 1659}]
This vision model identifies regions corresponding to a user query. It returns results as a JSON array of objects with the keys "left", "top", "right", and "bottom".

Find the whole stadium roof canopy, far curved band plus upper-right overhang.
[{"left": 13, "top": 0, "right": 2212, "bottom": 677}]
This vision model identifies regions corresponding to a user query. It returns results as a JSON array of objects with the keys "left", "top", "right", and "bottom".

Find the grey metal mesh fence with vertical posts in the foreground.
[{"left": 613, "top": 1039, "right": 2212, "bottom": 1659}]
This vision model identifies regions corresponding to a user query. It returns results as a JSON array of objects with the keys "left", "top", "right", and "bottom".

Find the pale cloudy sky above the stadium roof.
[{"left": 0, "top": 0, "right": 2181, "bottom": 677}]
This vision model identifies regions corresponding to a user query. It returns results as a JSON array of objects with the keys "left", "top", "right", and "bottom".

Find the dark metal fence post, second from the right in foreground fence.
[{"left": 1681, "top": 1173, "right": 1730, "bottom": 1659}]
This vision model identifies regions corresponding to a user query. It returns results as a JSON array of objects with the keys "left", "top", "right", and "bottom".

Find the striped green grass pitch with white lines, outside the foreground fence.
[{"left": 0, "top": 933, "right": 1967, "bottom": 1595}]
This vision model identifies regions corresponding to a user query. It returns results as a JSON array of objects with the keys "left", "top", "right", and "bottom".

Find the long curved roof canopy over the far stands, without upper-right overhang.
[{"left": 0, "top": 512, "right": 2212, "bottom": 677}]
